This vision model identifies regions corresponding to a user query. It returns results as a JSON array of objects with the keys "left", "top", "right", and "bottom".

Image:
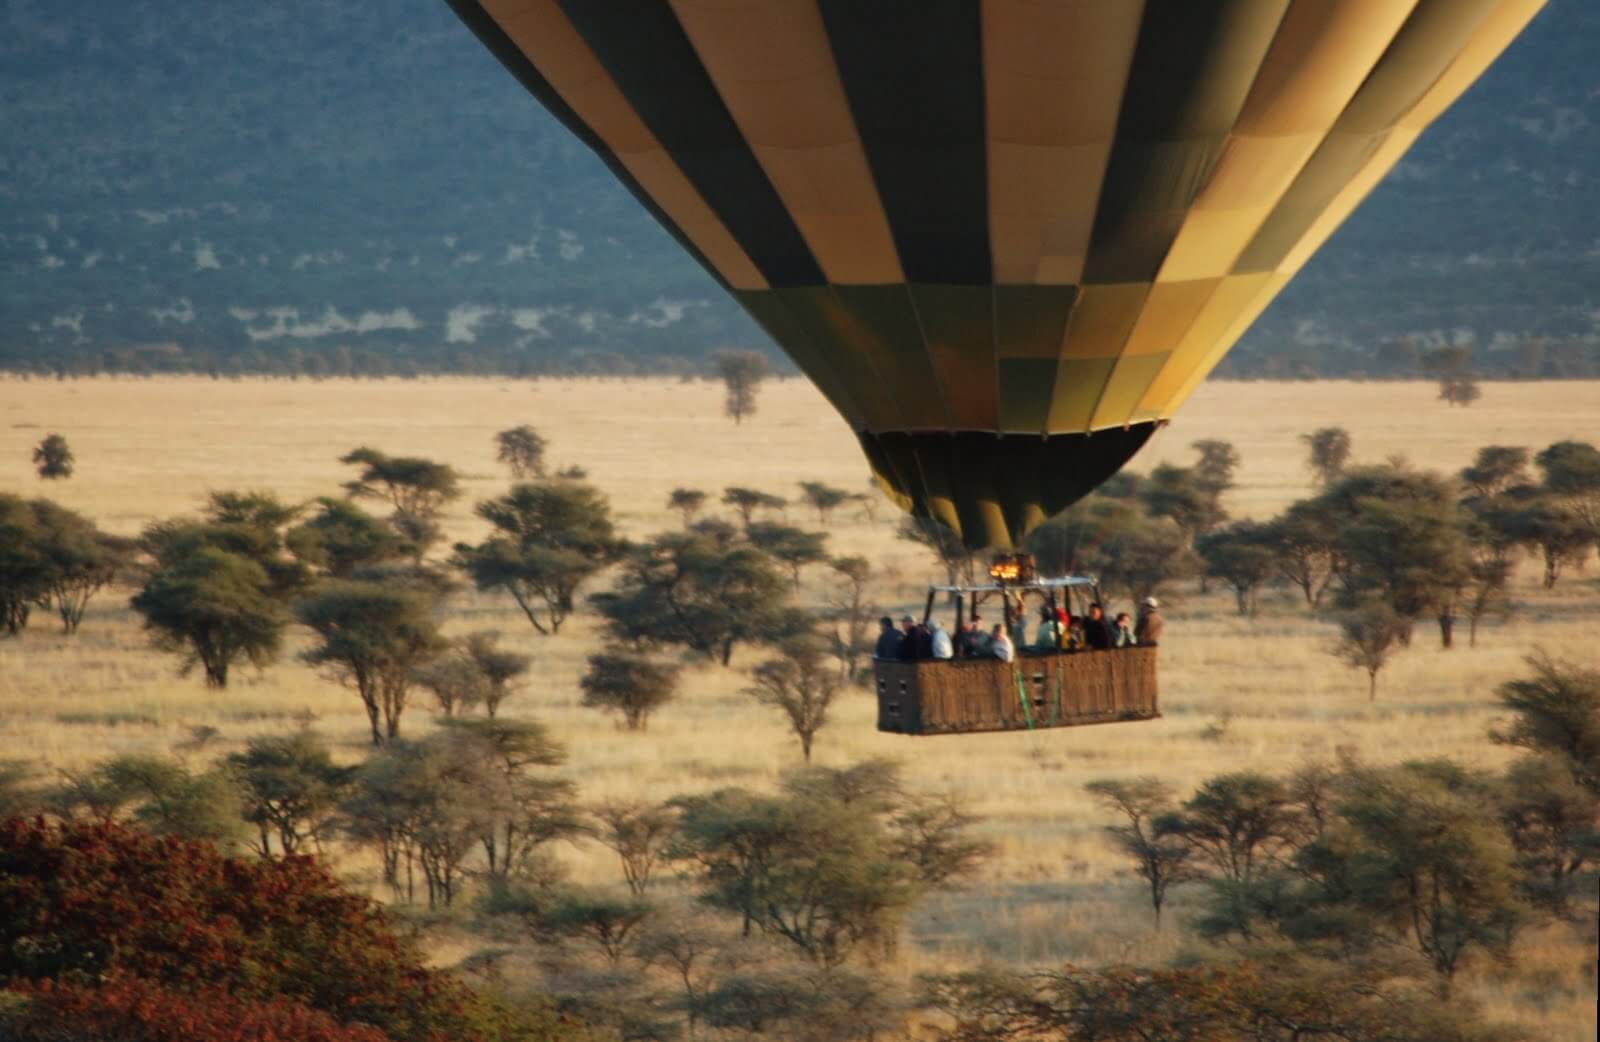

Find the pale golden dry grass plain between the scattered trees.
[{"left": 0, "top": 378, "right": 1600, "bottom": 1040}]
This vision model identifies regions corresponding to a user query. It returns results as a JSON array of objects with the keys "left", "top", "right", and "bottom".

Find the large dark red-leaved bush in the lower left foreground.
[{"left": 0, "top": 820, "right": 474, "bottom": 1039}]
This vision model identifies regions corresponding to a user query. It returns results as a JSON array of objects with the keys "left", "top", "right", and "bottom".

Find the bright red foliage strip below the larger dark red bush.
[{"left": 0, "top": 980, "right": 390, "bottom": 1042}]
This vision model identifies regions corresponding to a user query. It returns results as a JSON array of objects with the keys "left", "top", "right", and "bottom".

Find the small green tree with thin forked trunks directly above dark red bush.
[{"left": 224, "top": 731, "right": 354, "bottom": 858}]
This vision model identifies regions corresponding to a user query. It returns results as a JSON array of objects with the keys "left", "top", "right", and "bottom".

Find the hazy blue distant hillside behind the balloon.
[{"left": 0, "top": 0, "right": 1600, "bottom": 375}]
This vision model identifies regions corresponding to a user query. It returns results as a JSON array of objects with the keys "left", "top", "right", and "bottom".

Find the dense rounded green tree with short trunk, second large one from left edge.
[{"left": 131, "top": 546, "right": 288, "bottom": 688}]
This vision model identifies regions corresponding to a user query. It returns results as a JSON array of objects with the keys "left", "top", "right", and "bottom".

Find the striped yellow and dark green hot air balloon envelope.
[{"left": 450, "top": 0, "right": 1544, "bottom": 547}]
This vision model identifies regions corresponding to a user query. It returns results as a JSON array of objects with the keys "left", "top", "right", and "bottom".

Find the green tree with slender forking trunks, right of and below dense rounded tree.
[{"left": 294, "top": 579, "right": 445, "bottom": 746}]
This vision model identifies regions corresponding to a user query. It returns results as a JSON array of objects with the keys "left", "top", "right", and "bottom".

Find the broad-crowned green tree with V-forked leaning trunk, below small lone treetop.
[{"left": 456, "top": 480, "right": 626, "bottom": 634}]
